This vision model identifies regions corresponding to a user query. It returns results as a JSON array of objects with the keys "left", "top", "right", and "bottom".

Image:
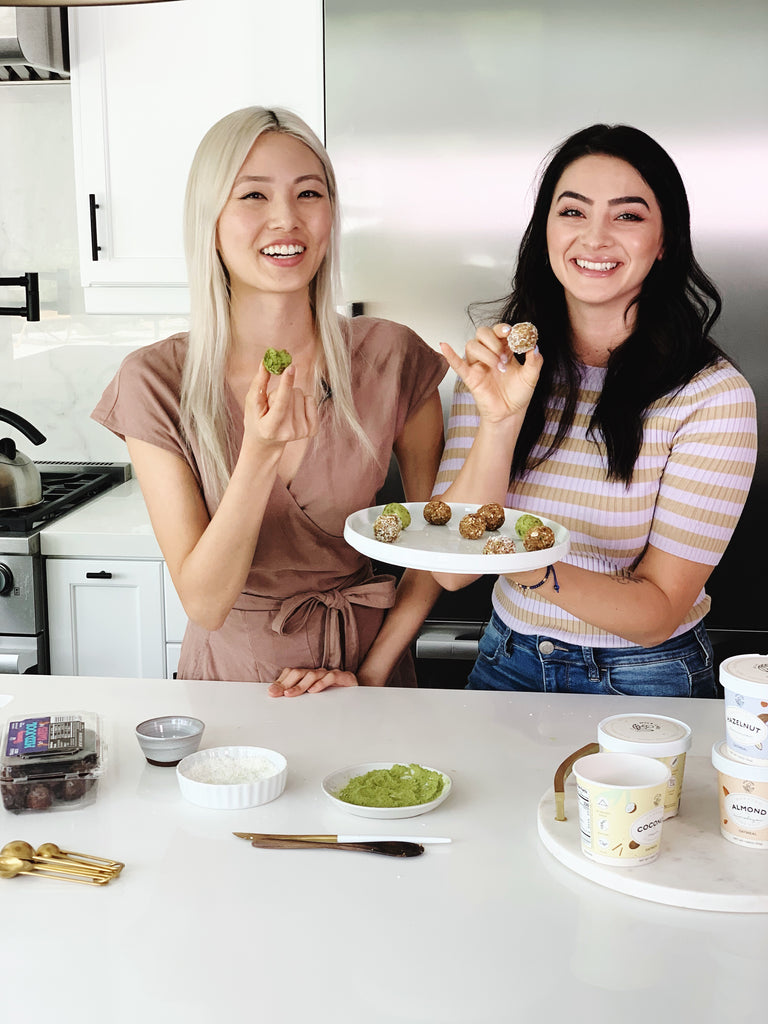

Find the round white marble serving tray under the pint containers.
[{"left": 539, "top": 756, "right": 768, "bottom": 913}]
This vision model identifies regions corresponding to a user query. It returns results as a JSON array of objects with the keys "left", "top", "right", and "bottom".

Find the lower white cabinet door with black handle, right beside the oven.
[{"left": 46, "top": 558, "right": 165, "bottom": 679}]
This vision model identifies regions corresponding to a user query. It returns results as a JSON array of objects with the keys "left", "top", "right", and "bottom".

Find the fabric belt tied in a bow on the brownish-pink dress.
[{"left": 272, "top": 575, "right": 394, "bottom": 671}]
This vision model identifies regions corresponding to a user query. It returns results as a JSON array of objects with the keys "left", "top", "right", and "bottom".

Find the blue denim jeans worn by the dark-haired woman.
[{"left": 467, "top": 612, "right": 718, "bottom": 697}]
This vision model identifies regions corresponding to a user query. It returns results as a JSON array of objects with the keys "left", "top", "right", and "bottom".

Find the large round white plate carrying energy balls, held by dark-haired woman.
[{"left": 344, "top": 502, "right": 570, "bottom": 575}]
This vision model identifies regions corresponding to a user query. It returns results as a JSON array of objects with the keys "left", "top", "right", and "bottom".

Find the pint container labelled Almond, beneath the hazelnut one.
[{"left": 712, "top": 740, "right": 768, "bottom": 851}]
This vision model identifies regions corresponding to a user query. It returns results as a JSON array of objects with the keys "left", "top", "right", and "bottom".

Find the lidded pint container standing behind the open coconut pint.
[{"left": 597, "top": 715, "right": 691, "bottom": 818}]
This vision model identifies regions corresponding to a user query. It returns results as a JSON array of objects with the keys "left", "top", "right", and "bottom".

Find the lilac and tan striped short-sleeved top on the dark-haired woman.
[{"left": 435, "top": 359, "right": 757, "bottom": 647}]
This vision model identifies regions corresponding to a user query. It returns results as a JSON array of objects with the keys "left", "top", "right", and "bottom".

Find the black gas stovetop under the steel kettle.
[{"left": 0, "top": 462, "right": 131, "bottom": 551}]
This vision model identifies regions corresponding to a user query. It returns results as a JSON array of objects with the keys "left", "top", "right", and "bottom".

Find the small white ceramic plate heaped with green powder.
[{"left": 323, "top": 761, "right": 451, "bottom": 818}]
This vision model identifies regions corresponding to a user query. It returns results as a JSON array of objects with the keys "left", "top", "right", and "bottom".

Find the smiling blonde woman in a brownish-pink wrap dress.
[{"left": 92, "top": 106, "right": 446, "bottom": 696}]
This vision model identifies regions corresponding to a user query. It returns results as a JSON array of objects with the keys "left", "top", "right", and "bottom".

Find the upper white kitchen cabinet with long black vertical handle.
[{"left": 70, "top": 0, "right": 325, "bottom": 313}]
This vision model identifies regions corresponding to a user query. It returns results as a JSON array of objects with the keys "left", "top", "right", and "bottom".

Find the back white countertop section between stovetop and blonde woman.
[{"left": 40, "top": 478, "right": 163, "bottom": 558}]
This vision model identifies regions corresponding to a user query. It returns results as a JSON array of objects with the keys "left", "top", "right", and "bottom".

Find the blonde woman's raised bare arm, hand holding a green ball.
[{"left": 126, "top": 367, "right": 317, "bottom": 630}]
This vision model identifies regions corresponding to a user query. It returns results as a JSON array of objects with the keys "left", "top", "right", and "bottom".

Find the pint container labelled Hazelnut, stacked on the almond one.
[{"left": 720, "top": 654, "right": 768, "bottom": 766}]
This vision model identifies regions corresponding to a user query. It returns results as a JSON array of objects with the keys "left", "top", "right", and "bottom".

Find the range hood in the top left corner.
[{"left": 0, "top": 7, "right": 70, "bottom": 85}]
